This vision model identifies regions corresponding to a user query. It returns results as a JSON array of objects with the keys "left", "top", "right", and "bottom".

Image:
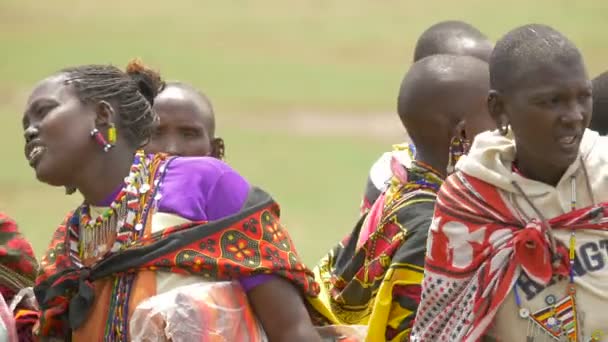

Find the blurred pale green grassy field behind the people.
[{"left": 0, "top": 0, "right": 608, "bottom": 263}]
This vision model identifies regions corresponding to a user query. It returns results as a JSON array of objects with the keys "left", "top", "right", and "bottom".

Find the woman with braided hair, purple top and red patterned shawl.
[{"left": 23, "top": 61, "right": 320, "bottom": 341}]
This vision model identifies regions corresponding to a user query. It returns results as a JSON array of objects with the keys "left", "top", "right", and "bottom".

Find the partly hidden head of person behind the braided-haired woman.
[{"left": 145, "top": 85, "right": 221, "bottom": 158}]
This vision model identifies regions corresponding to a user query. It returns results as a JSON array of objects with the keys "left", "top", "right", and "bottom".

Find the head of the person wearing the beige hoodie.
[{"left": 488, "top": 24, "right": 592, "bottom": 186}]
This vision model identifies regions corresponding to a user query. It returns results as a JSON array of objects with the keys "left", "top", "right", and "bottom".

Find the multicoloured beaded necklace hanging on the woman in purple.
[{"left": 70, "top": 151, "right": 167, "bottom": 341}]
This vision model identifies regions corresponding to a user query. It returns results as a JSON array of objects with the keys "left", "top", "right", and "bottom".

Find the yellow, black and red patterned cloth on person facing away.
[{"left": 310, "top": 158, "right": 442, "bottom": 341}]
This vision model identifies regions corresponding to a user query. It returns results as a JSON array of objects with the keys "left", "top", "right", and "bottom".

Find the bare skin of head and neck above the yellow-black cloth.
[{"left": 400, "top": 57, "right": 494, "bottom": 173}]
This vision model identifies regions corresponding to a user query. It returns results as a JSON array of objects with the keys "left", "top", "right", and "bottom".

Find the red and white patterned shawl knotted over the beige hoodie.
[{"left": 411, "top": 172, "right": 608, "bottom": 341}]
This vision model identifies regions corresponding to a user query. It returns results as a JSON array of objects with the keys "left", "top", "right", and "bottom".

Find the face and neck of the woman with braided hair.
[{"left": 23, "top": 75, "right": 136, "bottom": 203}]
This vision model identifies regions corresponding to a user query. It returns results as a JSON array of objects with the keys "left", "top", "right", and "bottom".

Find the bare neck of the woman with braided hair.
[{"left": 76, "top": 146, "right": 135, "bottom": 204}]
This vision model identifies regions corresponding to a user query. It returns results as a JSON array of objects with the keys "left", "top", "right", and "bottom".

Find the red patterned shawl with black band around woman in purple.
[{"left": 35, "top": 188, "right": 319, "bottom": 337}]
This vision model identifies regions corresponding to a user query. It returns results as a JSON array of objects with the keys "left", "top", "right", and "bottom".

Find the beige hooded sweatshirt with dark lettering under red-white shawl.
[{"left": 457, "top": 130, "right": 608, "bottom": 342}]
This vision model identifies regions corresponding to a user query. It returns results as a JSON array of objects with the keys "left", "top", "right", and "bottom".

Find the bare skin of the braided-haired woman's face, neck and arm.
[{"left": 23, "top": 74, "right": 320, "bottom": 341}]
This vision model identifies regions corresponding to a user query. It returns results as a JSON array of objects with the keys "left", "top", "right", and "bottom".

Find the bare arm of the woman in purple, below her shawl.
[{"left": 247, "top": 277, "right": 321, "bottom": 342}]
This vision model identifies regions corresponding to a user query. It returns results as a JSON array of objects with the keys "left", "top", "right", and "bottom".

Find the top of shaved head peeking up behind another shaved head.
[{"left": 414, "top": 20, "right": 492, "bottom": 62}]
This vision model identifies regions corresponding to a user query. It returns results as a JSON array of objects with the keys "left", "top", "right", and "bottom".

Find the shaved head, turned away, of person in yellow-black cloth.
[{"left": 397, "top": 55, "right": 493, "bottom": 163}]
